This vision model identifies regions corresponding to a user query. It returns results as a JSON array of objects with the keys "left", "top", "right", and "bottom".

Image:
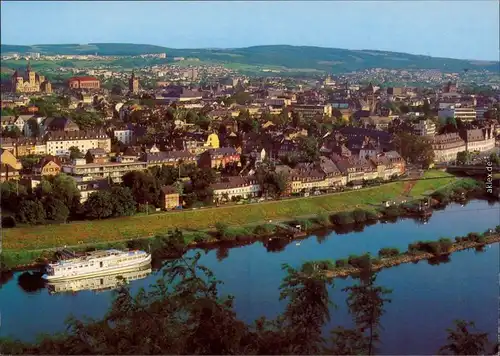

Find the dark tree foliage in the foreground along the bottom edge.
[{"left": 0, "top": 254, "right": 496, "bottom": 355}]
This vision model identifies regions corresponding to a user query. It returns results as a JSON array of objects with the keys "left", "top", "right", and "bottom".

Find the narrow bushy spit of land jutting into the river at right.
[{"left": 322, "top": 231, "right": 500, "bottom": 278}]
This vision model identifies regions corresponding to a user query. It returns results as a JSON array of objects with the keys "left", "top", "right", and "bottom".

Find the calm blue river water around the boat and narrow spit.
[{"left": 0, "top": 201, "right": 500, "bottom": 354}]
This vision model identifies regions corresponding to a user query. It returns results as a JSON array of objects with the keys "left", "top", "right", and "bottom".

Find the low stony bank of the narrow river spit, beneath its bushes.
[{"left": 325, "top": 232, "right": 500, "bottom": 278}]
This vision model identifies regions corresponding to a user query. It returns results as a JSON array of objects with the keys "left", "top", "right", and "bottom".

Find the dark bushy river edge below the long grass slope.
[{"left": 2, "top": 175, "right": 488, "bottom": 270}]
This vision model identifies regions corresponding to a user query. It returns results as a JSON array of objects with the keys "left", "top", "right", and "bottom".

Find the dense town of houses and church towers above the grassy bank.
[{"left": 1, "top": 59, "right": 500, "bottom": 218}]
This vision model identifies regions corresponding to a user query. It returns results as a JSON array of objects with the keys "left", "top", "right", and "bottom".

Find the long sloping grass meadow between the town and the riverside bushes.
[{"left": 2, "top": 171, "right": 461, "bottom": 251}]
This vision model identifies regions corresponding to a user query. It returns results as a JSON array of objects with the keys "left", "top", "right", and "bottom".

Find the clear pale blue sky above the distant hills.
[{"left": 0, "top": 0, "right": 500, "bottom": 60}]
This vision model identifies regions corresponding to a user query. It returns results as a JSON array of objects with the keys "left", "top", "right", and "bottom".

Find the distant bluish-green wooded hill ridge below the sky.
[{"left": 0, "top": 43, "right": 499, "bottom": 73}]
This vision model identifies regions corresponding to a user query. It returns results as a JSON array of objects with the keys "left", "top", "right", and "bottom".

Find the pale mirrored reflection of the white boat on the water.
[{"left": 47, "top": 266, "right": 151, "bottom": 295}]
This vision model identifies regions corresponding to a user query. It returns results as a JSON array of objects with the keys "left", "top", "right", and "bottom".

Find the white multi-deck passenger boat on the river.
[{"left": 42, "top": 249, "right": 151, "bottom": 282}]
